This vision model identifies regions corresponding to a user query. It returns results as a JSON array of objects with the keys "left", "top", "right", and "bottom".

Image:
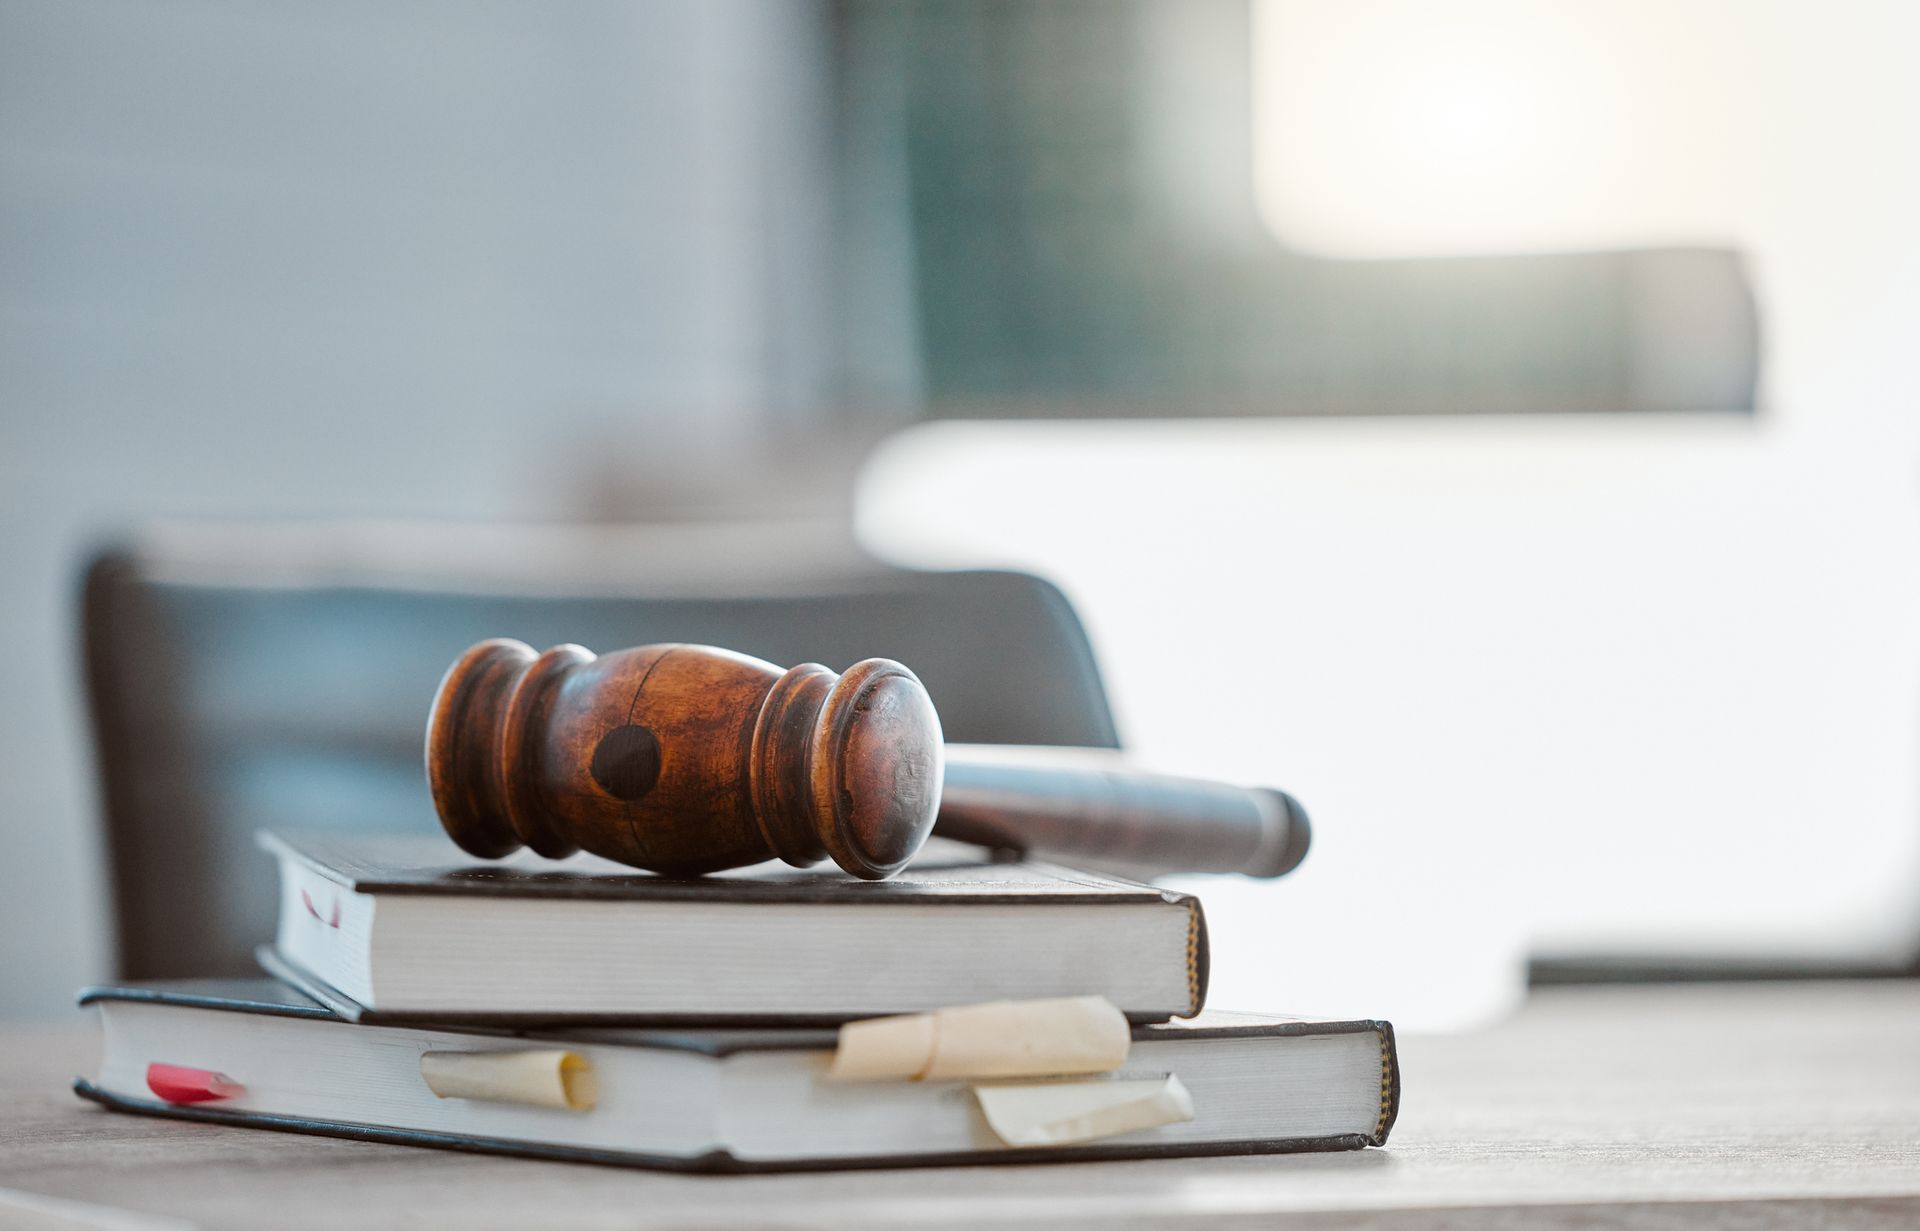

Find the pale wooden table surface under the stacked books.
[{"left": 0, "top": 981, "right": 1920, "bottom": 1231}]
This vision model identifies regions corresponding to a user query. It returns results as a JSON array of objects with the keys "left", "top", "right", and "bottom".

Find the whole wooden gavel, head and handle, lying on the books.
[{"left": 426, "top": 640, "right": 1309, "bottom": 880}]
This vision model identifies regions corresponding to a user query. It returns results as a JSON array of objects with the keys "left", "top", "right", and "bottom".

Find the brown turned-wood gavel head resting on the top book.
[{"left": 426, "top": 640, "right": 943, "bottom": 880}]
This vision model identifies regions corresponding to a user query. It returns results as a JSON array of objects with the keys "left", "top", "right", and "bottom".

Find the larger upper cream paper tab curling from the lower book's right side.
[{"left": 828, "top": 997, "right": 1133, "bottom": 1081}]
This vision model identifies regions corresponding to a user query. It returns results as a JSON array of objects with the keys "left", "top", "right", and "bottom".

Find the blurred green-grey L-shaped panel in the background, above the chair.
[{"left": 839, "top": 0, "right": 1757, "bottom": 415}]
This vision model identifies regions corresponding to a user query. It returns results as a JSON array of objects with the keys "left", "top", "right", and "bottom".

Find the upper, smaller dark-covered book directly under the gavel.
[{"left": 261, "top": 833, "right": 1208, "bottom": 1026}]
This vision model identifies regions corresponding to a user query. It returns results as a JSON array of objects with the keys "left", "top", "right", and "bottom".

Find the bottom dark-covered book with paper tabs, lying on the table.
[{"left": 75, "top": 979, "right": 1400, "bottom": 1171}]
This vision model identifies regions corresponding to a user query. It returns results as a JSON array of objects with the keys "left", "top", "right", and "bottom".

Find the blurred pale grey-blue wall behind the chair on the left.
[{"left": 0, "top": 0, "right": 856, "bottom": 1010}]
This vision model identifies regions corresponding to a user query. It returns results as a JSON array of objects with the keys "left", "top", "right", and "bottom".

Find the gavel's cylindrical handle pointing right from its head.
[{"left": 933, "top": 743, "right": 1311, "bottom": 876}]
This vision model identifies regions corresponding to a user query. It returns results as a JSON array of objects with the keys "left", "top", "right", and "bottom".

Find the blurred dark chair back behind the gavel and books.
[{"left": 84, "top": 526, "right": 1116, "bottom": 978}]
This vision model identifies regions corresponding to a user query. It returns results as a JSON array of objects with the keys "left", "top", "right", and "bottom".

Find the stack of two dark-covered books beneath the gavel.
[{"left": 75, "top": 835, "right": 1400, "bottom": 1171}]
